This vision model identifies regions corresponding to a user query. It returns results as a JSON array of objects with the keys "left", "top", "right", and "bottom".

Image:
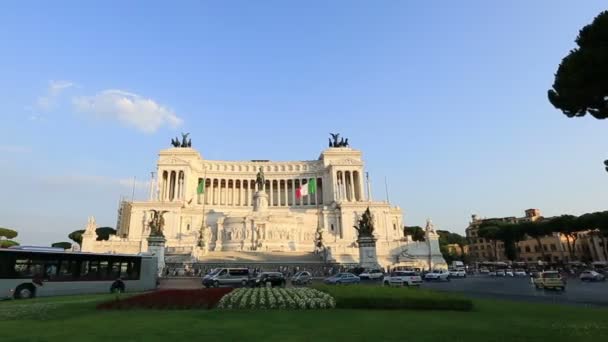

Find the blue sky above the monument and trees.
[{"left": 0, "top": 0, "right": 608, "bottom": 244}]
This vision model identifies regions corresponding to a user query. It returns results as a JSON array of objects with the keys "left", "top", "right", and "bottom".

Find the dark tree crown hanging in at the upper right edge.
[{"left": 548, "top": 11, "right": 608, "bottom": 119}]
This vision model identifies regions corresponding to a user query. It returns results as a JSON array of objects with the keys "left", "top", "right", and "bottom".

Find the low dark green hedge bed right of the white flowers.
[{"left": 315, "top": 285, "right": 473, "bottom": 311}]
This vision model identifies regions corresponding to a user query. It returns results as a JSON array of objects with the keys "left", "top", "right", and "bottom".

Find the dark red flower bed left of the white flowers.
[{"left": 97, "top": 288, "right": 232, "bottom": 310}]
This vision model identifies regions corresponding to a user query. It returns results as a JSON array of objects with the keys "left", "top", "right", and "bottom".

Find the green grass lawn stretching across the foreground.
[{"left": 0, "top": 295, "right": 608, "bottom": 342}]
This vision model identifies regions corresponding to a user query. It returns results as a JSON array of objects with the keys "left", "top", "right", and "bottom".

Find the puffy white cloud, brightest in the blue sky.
[{"left": 72, "top": 89, "right": 183, "bottom": 133}]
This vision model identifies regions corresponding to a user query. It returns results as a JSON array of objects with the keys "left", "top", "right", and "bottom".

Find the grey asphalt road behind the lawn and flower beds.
[{"left": 161, "top": 276, "right": 608, "bottom": 306}]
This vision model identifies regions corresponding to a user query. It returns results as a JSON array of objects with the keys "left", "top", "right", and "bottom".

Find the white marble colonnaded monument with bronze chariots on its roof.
[{"left": 83, "top": 134, "right": 446, "bottom": 267}]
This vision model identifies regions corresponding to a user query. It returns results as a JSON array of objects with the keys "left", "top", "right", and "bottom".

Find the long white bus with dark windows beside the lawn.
[{"left": 0, "top": 247, "right": 157, "bottom": 299}]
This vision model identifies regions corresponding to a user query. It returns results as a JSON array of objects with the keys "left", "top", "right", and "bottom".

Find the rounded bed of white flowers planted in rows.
[{"left": 217, "top": 287, "right": 336, "bottom": 310}]
